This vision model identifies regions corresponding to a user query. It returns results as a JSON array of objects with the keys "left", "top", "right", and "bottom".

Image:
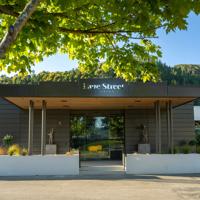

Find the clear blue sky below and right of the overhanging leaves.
[{"left": 32, "top": 14, "right": 200, "bottom": 73}]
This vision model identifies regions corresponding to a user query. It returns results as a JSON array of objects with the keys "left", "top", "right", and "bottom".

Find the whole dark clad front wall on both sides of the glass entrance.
[{"left": 0, "top": 99, "right": 194, "bottom": 154}]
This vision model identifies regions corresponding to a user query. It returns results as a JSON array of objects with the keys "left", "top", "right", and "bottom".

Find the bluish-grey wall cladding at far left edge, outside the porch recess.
[{"left": 0, "top": 98, "right": 20, "bottom": 143}]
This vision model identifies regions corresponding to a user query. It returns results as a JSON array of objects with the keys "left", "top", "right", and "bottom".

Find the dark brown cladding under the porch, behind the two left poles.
[{"left": 21, "top": 109, "right": 70, "bottom": 154}]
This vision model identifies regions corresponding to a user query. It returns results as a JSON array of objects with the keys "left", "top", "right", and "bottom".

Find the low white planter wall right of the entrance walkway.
[{"left": 126, "top": 154, "right": 200, "bottom": 174}]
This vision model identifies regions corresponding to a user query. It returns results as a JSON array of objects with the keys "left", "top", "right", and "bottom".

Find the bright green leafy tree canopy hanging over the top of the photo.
[{"left": 0, "top": 0, "right": 200, "bottom": 81}]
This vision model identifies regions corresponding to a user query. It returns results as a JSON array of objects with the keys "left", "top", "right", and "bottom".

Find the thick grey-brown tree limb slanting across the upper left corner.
[{"left": 0, "top": 0, "right": 42, "bottom": 59}]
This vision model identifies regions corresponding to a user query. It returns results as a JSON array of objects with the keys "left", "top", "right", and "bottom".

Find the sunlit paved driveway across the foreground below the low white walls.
[{"left": 0, "top": 175, "right": 200, "bottom": 200}]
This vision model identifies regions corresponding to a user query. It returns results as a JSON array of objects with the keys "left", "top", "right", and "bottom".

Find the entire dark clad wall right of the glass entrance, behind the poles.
[{"left": 125, "top": 103, "right": 195, "bottom": 153}]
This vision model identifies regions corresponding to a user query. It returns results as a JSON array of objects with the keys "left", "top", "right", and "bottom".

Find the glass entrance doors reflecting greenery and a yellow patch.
[{"left": 70, "top": 115, "right": 124, "bottom": 160}]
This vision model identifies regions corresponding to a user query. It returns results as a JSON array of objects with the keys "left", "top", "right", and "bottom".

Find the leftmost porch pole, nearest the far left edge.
[{"left": 28, "top": 100, "right": 34, "bottom": 155}]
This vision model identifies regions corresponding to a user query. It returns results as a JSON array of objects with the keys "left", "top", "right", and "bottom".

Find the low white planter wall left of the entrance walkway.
[{"left": 0, "top": 154, "right": 79, "bottom": 176}]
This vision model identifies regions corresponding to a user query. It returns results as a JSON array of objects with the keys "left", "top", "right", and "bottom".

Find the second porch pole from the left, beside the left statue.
[{"left": 41, "top": 100, "right": 46, "bottom": 155}]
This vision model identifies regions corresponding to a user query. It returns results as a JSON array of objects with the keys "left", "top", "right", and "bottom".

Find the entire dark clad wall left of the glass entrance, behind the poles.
[{"left": 0, "top": 99, "right": 70, "bottom": 154}]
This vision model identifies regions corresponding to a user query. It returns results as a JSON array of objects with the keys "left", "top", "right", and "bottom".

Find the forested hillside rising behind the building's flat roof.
[{"left": 0, "top": 62, "right": 200, "bottom": 86}]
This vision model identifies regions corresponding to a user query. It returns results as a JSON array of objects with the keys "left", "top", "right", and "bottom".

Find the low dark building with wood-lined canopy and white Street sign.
[{"left": 0, "top": 79, "right": 197, "bottom": 159}]
